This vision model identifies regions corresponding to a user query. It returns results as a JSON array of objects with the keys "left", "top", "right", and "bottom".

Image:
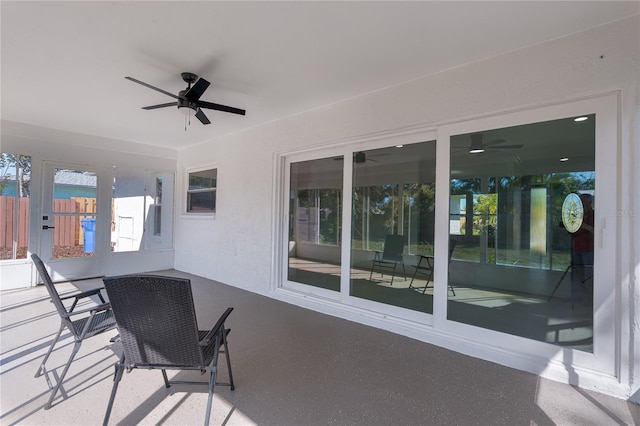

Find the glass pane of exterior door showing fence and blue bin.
[{"left": 51, "top": 168, "right": 98, "bottom": 259}]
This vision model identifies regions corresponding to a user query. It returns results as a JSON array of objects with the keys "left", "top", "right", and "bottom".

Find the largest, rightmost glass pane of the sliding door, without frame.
[{"left": 447, "top": 115, "right": 596, "bottom": 352}]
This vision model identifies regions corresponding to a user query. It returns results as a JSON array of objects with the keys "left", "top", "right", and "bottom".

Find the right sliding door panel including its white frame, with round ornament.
[{"left": 434, "top": 96, "right": 617, "bottom": 374}]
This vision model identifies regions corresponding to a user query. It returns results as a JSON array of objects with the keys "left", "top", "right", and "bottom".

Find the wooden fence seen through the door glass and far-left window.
[{"left": 0, "top": 196, "right": 96, "bottom": 249}]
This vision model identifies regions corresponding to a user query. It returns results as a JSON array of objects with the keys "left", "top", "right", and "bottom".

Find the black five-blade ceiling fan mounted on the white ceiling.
[{"left": 125, "top": 72, "right": 246, "bottom": 124}]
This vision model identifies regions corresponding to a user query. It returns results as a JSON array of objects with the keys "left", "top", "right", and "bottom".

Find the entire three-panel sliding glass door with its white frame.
[{"left": 282, "top": 96, "right": 617, "bottom": 374}]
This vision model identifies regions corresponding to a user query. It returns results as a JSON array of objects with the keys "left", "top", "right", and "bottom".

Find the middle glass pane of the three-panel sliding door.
[{"left": 350, "top": 141, "right": 436, "bottom": 313}]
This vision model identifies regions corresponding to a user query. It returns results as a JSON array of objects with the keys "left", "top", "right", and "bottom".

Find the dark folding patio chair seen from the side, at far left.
[{"left": 31, "top": 254, "right": 116, "bottom": 410}]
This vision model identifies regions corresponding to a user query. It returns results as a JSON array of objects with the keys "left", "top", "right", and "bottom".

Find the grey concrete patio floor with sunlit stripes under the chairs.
[{"left": 0, "top": 271, "right": 640, "bottom": 425}]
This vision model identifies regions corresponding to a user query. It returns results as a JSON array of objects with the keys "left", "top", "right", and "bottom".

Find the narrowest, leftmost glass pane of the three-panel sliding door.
[{"left": 288, "top": 156, "right": 343, "bottom": 292}]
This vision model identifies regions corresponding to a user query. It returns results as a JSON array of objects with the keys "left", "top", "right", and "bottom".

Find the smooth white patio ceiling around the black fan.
[{"left": 0, "top": 1, "right": 640, "bottom": 149}]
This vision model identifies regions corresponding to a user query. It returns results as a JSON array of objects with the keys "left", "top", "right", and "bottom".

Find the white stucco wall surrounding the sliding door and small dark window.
[{"left": 175, "top": 16, "right": 640, "bottom": 401}]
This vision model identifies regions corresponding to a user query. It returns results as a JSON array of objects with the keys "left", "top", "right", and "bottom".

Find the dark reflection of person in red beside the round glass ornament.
[{"left": 571, "top": 194, "right": 594, "bottom": 300}]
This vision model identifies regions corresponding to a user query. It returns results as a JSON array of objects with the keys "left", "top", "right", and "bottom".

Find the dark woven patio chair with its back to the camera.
[{"left": 103, "top": 275, "right": 235, "bottom": 425}]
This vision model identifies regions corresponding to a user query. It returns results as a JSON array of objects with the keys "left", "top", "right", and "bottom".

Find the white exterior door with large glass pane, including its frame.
[{"left": 39, "top": 162, "right": 109, "bottom": 280}]
